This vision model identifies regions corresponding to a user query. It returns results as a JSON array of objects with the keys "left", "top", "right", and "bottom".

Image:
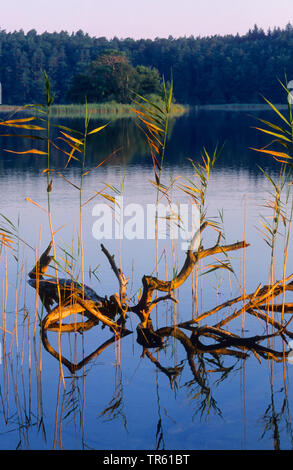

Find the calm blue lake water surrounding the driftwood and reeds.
[{"left": 0, "top": 111, "right": 293, "bottom": 450}]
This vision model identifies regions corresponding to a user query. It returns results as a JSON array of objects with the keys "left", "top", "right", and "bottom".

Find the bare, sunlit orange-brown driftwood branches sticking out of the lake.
[{"left": 28, "top": 223, "right": 293, "bottom": 380}]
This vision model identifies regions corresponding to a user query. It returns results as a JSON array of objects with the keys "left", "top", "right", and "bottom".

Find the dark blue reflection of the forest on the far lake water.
[{"left": 0, "top": 111, "right": 282, "bottom": 172}]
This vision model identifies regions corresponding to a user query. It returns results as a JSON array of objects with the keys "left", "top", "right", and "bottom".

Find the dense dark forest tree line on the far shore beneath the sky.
[{"left": 0, "top": 24, "right": 293, "bottom": 104}]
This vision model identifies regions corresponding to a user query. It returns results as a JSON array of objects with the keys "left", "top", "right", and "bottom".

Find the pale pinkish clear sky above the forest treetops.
[{"left": 0, "top": 0, "right": 293, "bottom": 39}]
